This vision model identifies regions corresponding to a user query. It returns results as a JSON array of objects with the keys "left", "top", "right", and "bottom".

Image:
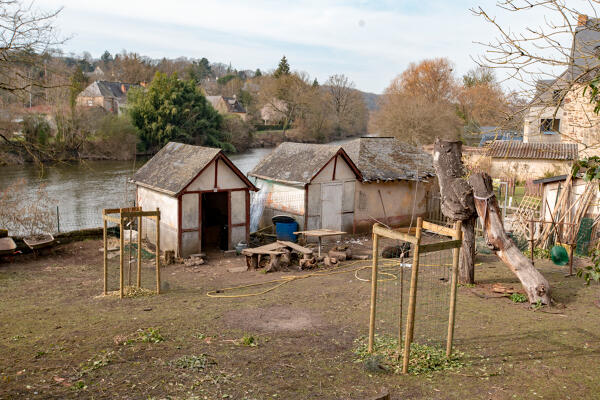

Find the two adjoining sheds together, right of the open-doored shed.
[{"left": 248, "top": 138, "right": 436, "bottom": 232}]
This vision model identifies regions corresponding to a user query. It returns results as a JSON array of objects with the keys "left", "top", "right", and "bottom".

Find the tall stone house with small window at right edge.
[{"left": 523, "top": 15, "right": 600, "bottom": 156}]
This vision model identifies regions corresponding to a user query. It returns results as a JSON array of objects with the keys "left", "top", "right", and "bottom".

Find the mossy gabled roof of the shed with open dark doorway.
[{"left": 133, "top": 142, "right": 256, "bottom": 196}]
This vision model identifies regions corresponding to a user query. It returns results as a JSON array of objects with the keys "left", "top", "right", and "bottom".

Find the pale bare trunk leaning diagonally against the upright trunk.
[{"left": 469, "top": 173, "right": 550, "bottom": 304}]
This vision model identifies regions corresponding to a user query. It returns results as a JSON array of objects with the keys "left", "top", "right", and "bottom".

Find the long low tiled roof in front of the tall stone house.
[{"left": 485, "top": 141, "right": 578, "bottom": 161}]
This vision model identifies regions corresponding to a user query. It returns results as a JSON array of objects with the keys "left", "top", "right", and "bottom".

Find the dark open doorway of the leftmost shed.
[{"left": 202, "top": 192, "right": 229, "bottom": 250}]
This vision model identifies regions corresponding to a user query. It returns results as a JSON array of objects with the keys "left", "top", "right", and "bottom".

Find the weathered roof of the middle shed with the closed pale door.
[{"left": 248, "top": 142, "right": 362, "bottom": 185}]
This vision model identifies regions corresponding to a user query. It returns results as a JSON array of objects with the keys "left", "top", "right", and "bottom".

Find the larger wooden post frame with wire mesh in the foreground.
[{"left": 369, "top": 217, "right": 462, "bottom": 374}]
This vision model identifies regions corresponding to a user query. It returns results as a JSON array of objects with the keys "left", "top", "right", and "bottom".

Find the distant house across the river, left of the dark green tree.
[{"left": 76, "top": 81, "right": 143, "bottom": 114}]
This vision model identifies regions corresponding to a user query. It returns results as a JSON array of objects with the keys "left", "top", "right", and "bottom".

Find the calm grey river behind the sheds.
[{"left": 0, "top": 139, "right": 351, "bottom": 234}]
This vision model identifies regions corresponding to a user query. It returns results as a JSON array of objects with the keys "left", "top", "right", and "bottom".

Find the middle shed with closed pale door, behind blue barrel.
[{"left": 248, "top": 142, "right": 362, "bottom": 232}]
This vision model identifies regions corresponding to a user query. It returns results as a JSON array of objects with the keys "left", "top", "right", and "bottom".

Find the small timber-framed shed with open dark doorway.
[{"left": 133, "top": 142, "right": 257, "bottom": 257}]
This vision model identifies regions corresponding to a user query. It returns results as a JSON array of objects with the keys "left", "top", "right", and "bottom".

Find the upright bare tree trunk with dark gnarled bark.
[{"left": 433, "top": 139, "right": 477, "bottom": 284}]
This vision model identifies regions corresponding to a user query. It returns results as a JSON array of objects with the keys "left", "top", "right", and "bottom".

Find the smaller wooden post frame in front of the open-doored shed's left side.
[{"left": 102, "top": 207, "right": 160, "bottom": 299}]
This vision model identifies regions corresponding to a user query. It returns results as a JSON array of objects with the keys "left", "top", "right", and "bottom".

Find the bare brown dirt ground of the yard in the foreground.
[{"left": 0, "top": 236, "right": 600, "bottom": 399}]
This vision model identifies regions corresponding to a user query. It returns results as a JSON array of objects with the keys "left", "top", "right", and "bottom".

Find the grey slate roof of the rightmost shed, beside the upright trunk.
[{"left": 342, "top": 137, "right": 435, "bottom": 182}]
